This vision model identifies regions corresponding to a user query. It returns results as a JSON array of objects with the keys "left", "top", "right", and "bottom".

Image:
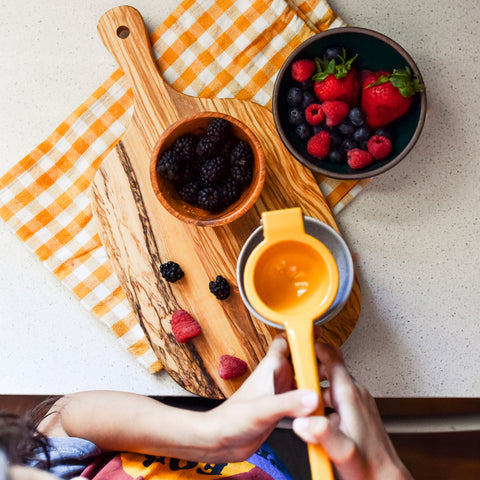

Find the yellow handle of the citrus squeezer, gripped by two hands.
[{"left": 285, "top": 321, "right": 334, "bottom": 480}]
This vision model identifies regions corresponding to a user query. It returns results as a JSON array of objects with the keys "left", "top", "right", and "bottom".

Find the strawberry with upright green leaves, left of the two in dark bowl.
[{"left": 312, "top": 49, "right": 361, "bottom": 107}]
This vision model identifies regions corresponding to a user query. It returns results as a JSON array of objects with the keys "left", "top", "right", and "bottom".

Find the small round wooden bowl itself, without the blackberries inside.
[{"left": 150, "top": 112, "right": 265, "bottom": 227}]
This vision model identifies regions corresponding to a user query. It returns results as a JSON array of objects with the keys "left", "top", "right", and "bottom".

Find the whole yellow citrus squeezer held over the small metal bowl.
[{"left": 243, "top": 208, "right": 339, "bottom": 480}]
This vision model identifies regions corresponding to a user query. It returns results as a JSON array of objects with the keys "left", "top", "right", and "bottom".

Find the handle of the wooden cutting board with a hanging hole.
[{"left": 97, "top": 6, "right": 178, "bottom": 146}]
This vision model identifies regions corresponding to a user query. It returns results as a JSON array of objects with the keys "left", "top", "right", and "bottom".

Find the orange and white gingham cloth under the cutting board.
[{"left": 0, "top": 0, "right": 367, "bottom": 373}]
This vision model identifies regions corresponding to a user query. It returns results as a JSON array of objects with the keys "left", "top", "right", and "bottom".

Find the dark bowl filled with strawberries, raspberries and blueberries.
[{"left": 273, "top": 27, "right": 426, "bottom": 180}]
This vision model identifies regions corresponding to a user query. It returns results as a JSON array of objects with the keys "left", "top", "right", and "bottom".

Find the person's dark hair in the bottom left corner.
[{"left": 0, "top": 397, "right": 59, "bottom": 470}]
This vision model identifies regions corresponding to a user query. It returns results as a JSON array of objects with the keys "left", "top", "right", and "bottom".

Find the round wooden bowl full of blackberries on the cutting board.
[{"left": 150, "top": 112, "right": 265, "bottom": 227}]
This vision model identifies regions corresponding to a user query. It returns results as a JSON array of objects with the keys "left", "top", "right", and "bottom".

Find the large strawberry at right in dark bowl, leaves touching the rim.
[{"left": 362, "top": 66, "right": 424, "bottom": 128}]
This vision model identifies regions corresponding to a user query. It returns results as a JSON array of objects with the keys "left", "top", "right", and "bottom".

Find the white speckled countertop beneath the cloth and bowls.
[{"left": 0, "top": 0, "right": 480, "bottom": 397}]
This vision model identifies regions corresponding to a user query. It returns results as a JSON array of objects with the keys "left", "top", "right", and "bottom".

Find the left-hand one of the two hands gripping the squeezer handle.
[{"left": 208, "top": 335, "right": 319, "bottom": 462}]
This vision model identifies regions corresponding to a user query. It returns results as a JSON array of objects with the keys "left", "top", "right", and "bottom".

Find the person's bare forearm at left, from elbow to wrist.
[{"left": 41, "top": 391, "right": 217, "bottom": 461}]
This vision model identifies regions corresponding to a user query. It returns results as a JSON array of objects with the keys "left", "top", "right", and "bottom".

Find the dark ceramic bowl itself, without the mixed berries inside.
[{"left": 272, "top": 27, "right": 427, "bottom": 180}]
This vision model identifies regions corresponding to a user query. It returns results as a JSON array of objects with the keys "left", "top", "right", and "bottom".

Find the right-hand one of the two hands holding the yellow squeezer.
[{"left": 293, "top": 343, "right": 413, "bottom": 480}]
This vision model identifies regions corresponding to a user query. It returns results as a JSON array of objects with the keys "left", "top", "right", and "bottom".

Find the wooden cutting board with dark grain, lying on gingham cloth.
[{"left": 92, "top": 7, "right": 360, "bottom": 398}]
